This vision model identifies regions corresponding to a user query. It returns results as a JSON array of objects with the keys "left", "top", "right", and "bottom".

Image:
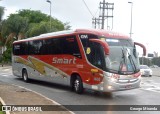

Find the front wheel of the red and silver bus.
[{"left": 73, "top": 76, "right": 83, "bottom": 94}]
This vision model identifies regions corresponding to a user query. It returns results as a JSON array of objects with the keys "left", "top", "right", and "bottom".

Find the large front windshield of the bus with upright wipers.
[{"left": 105, "top": 38, "right": 139, "bottom": 74}]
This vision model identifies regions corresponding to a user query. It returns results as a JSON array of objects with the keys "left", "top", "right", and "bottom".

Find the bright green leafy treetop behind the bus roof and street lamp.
[{"left": 18, "top": 10, "right": 68, "bottom": 37}]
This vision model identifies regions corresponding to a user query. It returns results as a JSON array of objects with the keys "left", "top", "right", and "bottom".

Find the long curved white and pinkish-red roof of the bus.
[{"left": 14, "top": 29, "right": 130, "bottom": 43}]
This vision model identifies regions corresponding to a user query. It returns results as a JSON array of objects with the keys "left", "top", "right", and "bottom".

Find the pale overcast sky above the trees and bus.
[{"left": 0, "top": 0, "right": 160, "bottom": 55}]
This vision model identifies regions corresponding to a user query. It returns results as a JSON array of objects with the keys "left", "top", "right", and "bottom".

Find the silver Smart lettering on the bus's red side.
[{"left": 52, "top": 57, "right": 76, "bottom": 64}]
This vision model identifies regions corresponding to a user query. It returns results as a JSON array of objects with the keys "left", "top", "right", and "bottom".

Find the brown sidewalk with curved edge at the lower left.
[{"left": 0, "top": 66, "right": 73, "bottom": 114}]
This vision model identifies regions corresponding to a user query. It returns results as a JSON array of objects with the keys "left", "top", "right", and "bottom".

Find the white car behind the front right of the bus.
[{"left": 140, "top": 65, "right": 152, "bottom": 77}]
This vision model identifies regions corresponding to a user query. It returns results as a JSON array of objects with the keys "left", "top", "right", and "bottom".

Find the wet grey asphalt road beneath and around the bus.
[{"left": 0, "top": 66, "right": 160, "bottom": 114}]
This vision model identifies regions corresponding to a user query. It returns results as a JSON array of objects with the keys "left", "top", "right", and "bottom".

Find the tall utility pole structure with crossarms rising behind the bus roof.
[{"left": 92, "top": 0, "right": 114, "bottom": 29}]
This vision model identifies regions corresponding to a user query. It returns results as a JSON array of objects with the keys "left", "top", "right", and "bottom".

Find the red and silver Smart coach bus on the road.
[{"left": 12, "top": 29, "right": 146, "bottom": 94}]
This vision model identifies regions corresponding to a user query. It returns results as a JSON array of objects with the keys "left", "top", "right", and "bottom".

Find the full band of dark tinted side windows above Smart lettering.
[{"left": 13, "top": 36, "right": 81, "bottom": 58}]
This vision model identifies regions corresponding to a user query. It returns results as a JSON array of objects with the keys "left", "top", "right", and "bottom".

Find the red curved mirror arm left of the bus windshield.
[{"left": 89, "top": 39, "right": 109, "bottom": 55}]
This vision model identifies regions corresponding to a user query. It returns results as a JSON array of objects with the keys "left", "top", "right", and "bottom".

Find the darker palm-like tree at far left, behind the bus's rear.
[{"left": 1, "top": 14, "right": 29, "bottom": 46}]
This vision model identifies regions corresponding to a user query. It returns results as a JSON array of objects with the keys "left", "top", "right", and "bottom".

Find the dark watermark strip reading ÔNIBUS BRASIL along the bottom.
[{"left": 2, "top": 105, "right": 160, "bottom": 112}]
